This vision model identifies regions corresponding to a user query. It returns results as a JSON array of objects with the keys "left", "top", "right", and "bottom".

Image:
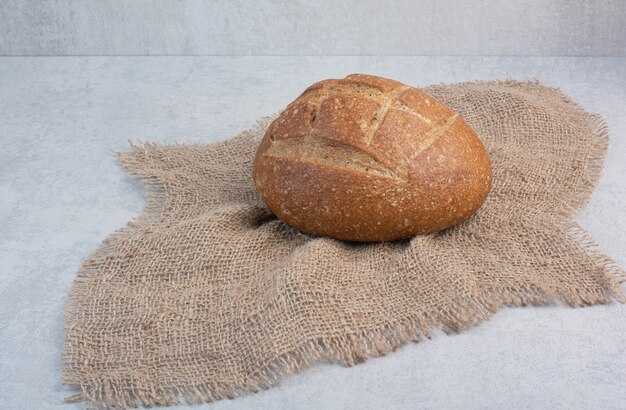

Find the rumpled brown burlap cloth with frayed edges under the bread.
[{"left": 64, "top": 81, "right": 626, "bottom": 407}]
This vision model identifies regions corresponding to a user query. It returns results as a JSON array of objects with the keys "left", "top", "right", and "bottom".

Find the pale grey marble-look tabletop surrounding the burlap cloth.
[{"left": 0, "top": 57, "right": 626, "bottom": 410}]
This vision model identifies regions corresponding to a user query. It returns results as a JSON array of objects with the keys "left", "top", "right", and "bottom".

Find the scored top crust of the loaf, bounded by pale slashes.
[{"left": 266, "top": 74, "right": 458, "bottom": 181}]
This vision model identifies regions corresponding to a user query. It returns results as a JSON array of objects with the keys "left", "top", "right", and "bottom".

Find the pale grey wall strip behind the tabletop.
[{"left": 0, "top": 0, "right": 626, "bottom": 56}]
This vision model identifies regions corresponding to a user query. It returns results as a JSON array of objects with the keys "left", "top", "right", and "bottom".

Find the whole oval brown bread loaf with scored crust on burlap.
[{"left": 253, "top": 74, "right": 492, "bottom": 241}]
